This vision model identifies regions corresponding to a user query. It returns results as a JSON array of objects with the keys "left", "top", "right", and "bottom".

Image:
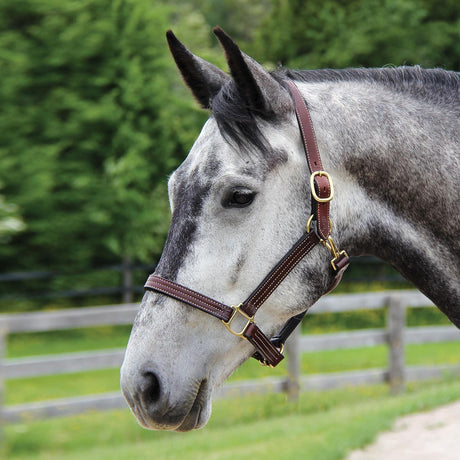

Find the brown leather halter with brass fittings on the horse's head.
[{"left": 144, "top": 81, "right": 350, "bottom": 367}]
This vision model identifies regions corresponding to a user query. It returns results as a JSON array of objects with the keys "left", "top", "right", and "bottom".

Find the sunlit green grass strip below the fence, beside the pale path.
[{"left": 5, "top": 381, "right": 460, "bottom": 460}]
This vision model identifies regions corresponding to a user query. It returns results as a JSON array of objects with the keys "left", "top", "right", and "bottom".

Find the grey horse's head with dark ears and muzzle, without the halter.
[{"left": 121, "top": 29, "right": 342, "bottom": 431}]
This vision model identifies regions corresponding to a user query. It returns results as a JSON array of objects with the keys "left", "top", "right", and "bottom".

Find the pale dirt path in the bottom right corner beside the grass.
[{"left": 346, "top": 401, "right": 460, "bottom": 460}]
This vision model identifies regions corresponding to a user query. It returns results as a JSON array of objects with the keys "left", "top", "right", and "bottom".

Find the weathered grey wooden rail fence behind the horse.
[{"left": 0, "top": 291, "right": 460, "bottom": 423}]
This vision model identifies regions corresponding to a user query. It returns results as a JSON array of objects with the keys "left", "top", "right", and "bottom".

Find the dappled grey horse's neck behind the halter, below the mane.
[{"left": 298, "top": 83, "right": 460, "bottom": 327}]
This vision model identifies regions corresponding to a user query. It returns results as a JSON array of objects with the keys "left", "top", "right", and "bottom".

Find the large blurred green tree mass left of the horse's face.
[{"left": 0, "top": 0, "right": 210, "bottom": 282}]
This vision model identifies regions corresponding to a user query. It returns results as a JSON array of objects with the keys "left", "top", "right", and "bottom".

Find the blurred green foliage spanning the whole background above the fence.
[{"left": 0, "top": 0, "right": 460, "bottom": 310}]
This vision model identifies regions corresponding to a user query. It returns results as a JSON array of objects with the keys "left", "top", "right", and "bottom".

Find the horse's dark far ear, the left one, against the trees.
[{"left": 166, "top": 30, "right": 230, "bottom": 109}]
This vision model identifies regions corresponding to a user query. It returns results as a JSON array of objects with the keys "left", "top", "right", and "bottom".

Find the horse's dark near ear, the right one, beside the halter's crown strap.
[{"left": 213, "top": 27, "right": 292, "bottom": 115}]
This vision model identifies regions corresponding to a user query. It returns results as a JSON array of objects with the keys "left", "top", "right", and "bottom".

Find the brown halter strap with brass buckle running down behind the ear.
[{"left": 286, "top": 80, "right": 332, "bottom": 240}]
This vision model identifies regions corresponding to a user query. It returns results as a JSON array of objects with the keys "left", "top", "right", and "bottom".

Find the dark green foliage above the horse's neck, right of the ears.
[{"left": 254, "top": 0, "right": 460, "bottom": 70}]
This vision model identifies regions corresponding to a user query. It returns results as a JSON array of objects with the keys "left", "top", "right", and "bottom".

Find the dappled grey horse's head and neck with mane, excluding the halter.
[{"left": 121, "top": 28, "right": 460, "bottom": 431}]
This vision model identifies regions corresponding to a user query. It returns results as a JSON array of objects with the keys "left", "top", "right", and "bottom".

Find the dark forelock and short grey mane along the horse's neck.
[{"left": 210, "top": 66, "right": 460, "bottom": 157}]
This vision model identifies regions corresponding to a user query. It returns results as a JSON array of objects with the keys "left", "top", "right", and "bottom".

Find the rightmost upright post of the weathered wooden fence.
[{"left": 387, "top": 295, "right": 406, "bottom": 394}]
